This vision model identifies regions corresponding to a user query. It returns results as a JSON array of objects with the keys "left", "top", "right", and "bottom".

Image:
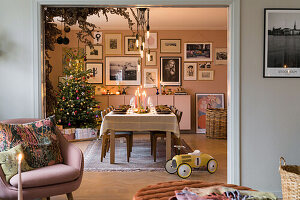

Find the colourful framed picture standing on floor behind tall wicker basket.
[{"left": 196, "top": 94, "right": 224, "bottom": 133}]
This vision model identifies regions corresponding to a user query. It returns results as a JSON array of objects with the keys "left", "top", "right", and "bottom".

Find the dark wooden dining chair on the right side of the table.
[{"left": 150, "top": 110, "right": 182, "bottom": 162}]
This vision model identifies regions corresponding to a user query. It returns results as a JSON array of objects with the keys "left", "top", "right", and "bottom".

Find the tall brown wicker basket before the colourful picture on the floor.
[{"left": 206, "top": 108, "right": 227, "bottom": 139}]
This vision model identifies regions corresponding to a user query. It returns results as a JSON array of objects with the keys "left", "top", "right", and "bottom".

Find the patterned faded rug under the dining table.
[{"left": 84, "top": 139, "right": 192, "bottom": 171}]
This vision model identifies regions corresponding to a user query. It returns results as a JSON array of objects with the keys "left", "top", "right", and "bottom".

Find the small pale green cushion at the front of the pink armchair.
[{"left": 0, "top": 144, "right": 33, "bottom": 182}]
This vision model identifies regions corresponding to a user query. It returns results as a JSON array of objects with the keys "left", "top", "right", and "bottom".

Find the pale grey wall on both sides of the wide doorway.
[{"left": 0, "top": 0, "right": 300, "bottom": 197}]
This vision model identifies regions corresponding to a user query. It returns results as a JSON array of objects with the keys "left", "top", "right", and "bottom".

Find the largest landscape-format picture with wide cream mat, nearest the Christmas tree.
[{"left": 105, "top": 56, "right": 141, "bottom": 85}]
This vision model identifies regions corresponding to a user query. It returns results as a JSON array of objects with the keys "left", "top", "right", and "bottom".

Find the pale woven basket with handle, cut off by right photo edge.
[{"left": 279, "top": 157, "right": 300, "bottom": 200}]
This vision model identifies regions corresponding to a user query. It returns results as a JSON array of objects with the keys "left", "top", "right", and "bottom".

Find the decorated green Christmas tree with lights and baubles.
[{"left": 55, "top": 50, "right": 99, "bottom": 128}]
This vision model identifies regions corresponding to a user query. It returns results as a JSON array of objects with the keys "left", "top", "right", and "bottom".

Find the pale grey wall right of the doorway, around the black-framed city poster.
[{"left": 241, "top": 0, "right": 300, "bottom": 195}]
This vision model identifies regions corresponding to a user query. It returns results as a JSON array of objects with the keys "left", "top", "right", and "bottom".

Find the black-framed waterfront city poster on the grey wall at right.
[{"left": 264, "top": 8, "right": 300, "bottom": 78}]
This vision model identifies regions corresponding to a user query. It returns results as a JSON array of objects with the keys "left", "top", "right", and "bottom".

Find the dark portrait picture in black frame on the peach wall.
[{"left": 160, "top": 57, "right": 181, "bottom": 85}]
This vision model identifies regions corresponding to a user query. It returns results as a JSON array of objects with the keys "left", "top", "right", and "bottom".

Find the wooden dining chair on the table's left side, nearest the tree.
[{"left": 101, "top": 111, "right": 133, "bottom": 162}]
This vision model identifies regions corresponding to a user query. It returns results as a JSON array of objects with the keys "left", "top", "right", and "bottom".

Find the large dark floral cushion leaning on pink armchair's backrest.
[{"left": 0, "top": 116, "right": 62, "bottom": 168}]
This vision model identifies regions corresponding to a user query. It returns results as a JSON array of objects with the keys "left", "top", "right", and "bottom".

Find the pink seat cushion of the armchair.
[{"left": 10, "top": 164, "right": 80, "bottom": 188}]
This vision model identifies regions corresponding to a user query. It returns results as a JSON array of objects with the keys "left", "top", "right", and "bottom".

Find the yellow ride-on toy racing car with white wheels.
[{"left": 165, "top": 150, "right": 218, "bottom": 178}]
